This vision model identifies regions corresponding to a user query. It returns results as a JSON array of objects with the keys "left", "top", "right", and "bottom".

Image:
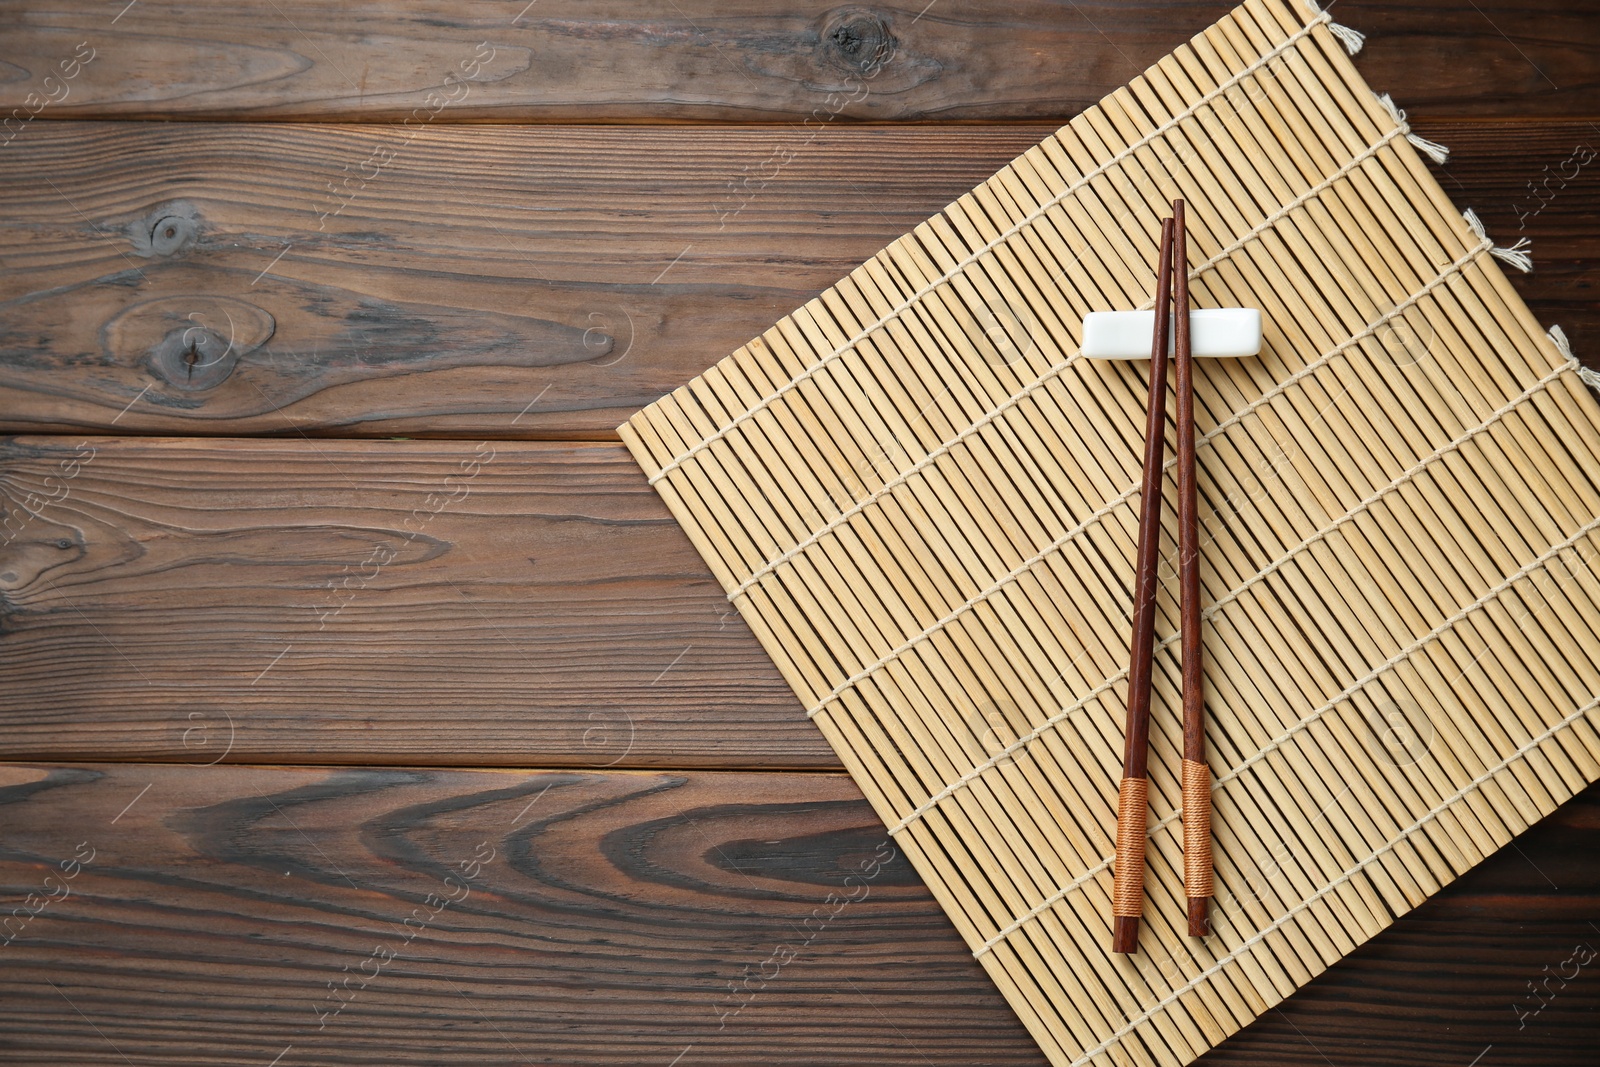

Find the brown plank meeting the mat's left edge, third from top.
[{"left": 0, "top": 437, "right": 838, "bottom": 768}]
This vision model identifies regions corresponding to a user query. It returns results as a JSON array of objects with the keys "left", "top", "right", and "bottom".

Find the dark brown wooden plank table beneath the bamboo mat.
[{"left": 0, "top": 0, "right": 1600, "bottom": 1067}]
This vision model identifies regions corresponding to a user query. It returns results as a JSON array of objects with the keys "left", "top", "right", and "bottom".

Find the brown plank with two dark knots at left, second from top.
[{"left": 0, "top": 123, "right": 1600, "bottom": 438}]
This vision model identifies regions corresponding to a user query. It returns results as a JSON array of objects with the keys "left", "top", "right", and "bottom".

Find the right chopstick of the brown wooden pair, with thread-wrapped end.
[{"left": 1173, "top": 200, "right": 1214, "bottom": 937}]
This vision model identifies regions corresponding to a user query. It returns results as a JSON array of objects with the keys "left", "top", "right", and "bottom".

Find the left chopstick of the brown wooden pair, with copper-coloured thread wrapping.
[{"left": 1110, "top": 212, "right": 1173, "bottom": 952}]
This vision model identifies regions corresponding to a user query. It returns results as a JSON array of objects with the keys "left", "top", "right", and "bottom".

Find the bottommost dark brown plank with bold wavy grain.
[{"left": 0, "top": 765, "right": 1600, "bottom": 1067}]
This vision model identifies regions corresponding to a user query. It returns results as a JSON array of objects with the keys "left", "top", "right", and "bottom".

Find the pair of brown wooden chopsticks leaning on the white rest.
[{"left": 1112, "top": 200, "right": 1211, "bottom": 952}]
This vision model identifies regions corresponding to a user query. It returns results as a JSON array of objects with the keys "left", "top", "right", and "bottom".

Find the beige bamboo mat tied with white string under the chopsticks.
[{"left": 621, "top": 0, "right": 1600, "bottom": 1064}]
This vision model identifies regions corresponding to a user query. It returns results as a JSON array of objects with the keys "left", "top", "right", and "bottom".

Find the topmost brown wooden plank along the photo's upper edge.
[{"left": 0, "top": 0, "right": 1600, "bottom": 123}]
